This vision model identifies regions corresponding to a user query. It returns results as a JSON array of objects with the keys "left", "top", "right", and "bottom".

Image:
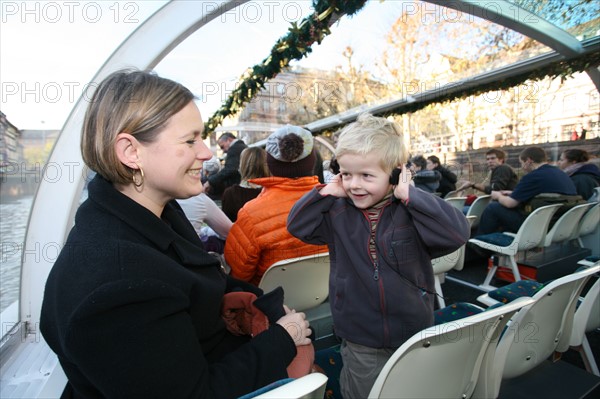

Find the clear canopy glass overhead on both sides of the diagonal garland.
[{"left": 155, "top": 1, "right": 564, "bottom": 138}]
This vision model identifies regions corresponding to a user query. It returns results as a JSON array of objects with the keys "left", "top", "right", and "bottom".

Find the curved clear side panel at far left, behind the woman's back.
[{"left": 0, "top": 1, "right": 165, "bottom": 336}]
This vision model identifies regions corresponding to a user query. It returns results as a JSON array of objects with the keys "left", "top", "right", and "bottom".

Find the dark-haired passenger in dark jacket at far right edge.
[{"left": 558, "top": 149, "right": 600, "bottom": 200}]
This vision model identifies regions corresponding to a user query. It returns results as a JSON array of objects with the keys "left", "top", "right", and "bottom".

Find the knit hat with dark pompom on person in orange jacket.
[{"left": 266, "top": 125, "right": 316, "bottom": 178}]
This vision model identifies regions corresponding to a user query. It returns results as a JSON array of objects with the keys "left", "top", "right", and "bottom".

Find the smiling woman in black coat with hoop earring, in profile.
[{"left": 40, "top": 71, "right": 310, "bottom": 398}]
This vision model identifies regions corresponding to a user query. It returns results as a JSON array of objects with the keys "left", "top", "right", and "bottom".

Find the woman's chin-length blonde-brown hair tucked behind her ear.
[{"left": 81, "top": 70, "right": 194, "bottom": 184}]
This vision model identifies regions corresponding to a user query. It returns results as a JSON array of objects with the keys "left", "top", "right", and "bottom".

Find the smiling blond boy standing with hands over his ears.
[{"left": 288, "top": 114, "right": 469, "bottom": 398}]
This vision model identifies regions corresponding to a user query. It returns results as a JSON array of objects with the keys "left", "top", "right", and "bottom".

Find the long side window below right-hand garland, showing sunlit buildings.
[{"left": 398, "top": 73, "right": 599, "bottom": 156}]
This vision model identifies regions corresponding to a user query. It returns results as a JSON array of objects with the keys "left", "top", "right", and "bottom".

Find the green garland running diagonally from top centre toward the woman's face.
[{"left": 203, "top": 0, "right": 366, "bottom": 138}]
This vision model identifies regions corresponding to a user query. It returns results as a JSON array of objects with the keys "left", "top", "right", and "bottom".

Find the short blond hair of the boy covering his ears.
[{"left": 335, "top": 113, "right": 408, "bottom": 172}]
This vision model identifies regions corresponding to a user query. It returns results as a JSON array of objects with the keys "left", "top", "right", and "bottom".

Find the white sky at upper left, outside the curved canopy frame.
[{"left": 0, "top": 0, "right": 165, "bottom": 130}]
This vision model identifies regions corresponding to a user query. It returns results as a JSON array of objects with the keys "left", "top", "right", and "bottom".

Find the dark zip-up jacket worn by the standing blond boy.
[{"left": 288, "top": 186, "right": 469, "bottom": 348}]
